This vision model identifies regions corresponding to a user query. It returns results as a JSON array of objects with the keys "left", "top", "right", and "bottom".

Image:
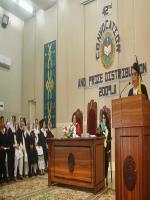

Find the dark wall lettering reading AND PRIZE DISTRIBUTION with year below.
[{"left": 78, "top": 62, "right": 147, "bottom": 98}]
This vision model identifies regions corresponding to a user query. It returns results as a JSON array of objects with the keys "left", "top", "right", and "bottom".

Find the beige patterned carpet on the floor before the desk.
[{"left": 0, "top": 176, "right": 115, "bottom": 200}]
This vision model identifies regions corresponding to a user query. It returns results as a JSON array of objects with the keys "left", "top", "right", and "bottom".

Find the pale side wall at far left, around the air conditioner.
[{"left": 0, "top": 7, "right": 24, "bottom": 117}]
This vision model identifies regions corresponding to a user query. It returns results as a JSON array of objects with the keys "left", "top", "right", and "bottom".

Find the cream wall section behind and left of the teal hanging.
[{"left": 22, "top": 5, "right": 57, "bottom": 119}]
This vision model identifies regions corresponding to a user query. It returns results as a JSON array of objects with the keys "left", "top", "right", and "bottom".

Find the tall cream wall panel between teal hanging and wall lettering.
[{"left": 57, "top": 0, "right": 85, "bottom": 126}]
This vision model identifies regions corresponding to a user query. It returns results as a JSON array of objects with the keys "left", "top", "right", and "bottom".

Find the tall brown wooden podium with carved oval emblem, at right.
[{"left": 112, "top": 95, "right": 150, "bottom": 200}]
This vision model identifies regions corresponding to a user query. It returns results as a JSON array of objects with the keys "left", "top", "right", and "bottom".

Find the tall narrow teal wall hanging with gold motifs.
[{"left": 44, "top": 41, "right": 56, "bottom": 128}]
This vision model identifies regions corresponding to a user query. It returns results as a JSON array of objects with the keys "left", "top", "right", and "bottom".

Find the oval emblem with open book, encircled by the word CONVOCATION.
[{"left": 101, "top": 32, "right": 115, "bottom": 69}]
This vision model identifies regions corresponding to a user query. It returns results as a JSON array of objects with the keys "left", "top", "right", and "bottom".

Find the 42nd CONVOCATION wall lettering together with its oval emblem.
[{"left": 95, "top": 0, "right": 121, "bottom": 69}]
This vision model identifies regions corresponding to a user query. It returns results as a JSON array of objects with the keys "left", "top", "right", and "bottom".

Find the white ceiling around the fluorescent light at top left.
[{"left": 0, "top": 0, "right": 57, "bottom": 21}]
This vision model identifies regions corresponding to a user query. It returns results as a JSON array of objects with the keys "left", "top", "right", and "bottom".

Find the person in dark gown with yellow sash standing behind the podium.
[{"left": 128, "top": 62, "right": 148, "bottom": 99}]
